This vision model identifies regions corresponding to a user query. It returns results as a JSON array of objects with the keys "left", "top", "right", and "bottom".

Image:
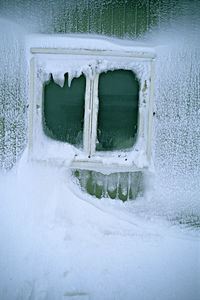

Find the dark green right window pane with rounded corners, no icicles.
[{"left": 96, "top": 70, "right": 139, "bottom": 151}]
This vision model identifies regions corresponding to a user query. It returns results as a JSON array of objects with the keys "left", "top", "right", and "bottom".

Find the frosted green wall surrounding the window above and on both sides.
[{"left": 0, "top": 0, "right": 200, "bottom": 214}]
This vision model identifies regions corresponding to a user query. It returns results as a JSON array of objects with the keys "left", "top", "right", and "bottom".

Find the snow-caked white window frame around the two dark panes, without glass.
[{"left": 28, "top": 48, "right": 155, "bottom": 173}]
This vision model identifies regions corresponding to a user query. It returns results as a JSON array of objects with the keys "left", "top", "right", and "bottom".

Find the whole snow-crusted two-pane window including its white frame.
[{"left": 29, "top": 48, "right": 154, "bottom": 176}]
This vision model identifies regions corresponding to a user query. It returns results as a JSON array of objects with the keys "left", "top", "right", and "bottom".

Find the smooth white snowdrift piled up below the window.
[{"left": 0, "top": 163, "right": 200, "bottom": 300}]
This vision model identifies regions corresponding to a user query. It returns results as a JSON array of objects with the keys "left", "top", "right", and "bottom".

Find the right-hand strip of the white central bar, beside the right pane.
[{"left": 90, "top": 74, "right": 99, "bottom": 155}]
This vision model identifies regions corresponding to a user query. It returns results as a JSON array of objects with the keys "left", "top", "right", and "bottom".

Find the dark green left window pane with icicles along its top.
[{"left": 43, "top": 74, "right": 86, "bottom": 147}]
